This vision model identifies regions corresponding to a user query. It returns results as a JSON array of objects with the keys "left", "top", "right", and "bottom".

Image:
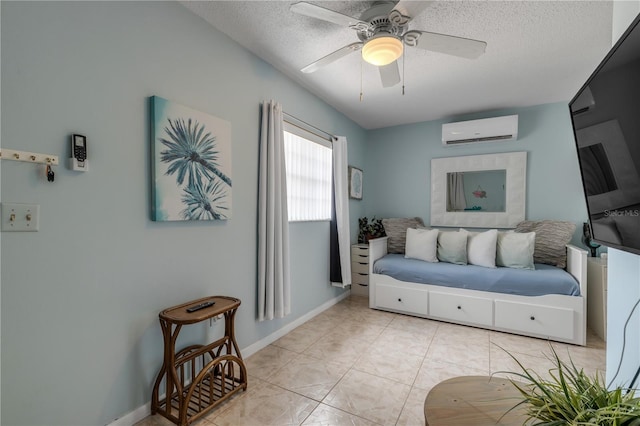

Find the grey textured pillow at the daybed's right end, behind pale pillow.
[{"left": 515, "top": 220, "right": 576, "bottom": 268}]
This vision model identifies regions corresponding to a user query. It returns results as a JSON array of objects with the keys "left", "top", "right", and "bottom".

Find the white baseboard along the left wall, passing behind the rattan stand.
[{"left": 108, "top": 291, "right": 351, "bottom": 426}]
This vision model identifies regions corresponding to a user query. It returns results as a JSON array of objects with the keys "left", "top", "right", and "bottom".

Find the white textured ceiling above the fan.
[{"left": 182, "top": 1, "right": 612, "bottom": 129}]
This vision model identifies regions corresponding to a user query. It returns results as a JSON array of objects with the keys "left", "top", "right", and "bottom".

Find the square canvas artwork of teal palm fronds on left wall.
[{"left": 150, "top": 96, "right": 231, "bottom": 221}]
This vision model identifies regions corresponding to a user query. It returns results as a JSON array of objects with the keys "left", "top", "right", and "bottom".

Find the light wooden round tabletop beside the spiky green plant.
[{"left": 424, "top": 376, "right": 527, "bottom": 426}]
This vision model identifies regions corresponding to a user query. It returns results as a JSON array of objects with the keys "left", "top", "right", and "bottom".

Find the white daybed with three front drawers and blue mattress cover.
[{"left": 369, "top": 221, "right": 587, "bottom": 346}]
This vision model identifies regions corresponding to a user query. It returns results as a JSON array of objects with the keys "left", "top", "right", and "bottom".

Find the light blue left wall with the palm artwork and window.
[{"left": 1, "top": 1, "right": 366, "bottom": 425}]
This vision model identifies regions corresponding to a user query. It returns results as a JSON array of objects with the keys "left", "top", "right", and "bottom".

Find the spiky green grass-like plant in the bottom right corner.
[{"left": 507, "top": 344, "right": 640, "bottom": 426}]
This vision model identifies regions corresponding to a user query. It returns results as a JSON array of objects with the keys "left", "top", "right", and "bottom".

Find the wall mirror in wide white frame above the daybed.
[{"left": 431, "top": 152, "right": 527, "bottom": 228}]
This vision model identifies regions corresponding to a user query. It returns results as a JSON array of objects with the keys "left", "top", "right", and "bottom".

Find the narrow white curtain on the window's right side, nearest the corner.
[{"left": 332, "top": 136, "right": 351, "bottom": 287}]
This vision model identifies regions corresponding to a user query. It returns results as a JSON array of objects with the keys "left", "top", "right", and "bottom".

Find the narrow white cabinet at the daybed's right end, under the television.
[{"left": 587, "top": 257, "right": 607, "bottom": 341}]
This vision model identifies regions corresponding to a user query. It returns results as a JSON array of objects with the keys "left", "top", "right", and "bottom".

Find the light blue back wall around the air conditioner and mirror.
[{"left": 364, "top": 103, "right": 587, "bottom": 243}]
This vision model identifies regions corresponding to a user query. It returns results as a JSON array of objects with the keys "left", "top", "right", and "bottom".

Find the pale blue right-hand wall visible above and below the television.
[{"left": 607, "top": 1, "right": 640, "bottom": 387}]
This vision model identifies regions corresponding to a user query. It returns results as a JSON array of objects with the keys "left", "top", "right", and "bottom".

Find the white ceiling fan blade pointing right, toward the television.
[{"left": 403, "top": 30, "right": 487, "bottom": 59}]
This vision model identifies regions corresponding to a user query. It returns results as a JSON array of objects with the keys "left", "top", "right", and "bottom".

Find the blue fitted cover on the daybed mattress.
[{"left": 373, "top": 254, "right": 580, "bottom": 296}]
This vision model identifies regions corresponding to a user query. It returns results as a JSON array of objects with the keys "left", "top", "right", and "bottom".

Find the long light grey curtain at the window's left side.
[{"left": 258, "top": 101, "right": 291, "bottom": 321}]
